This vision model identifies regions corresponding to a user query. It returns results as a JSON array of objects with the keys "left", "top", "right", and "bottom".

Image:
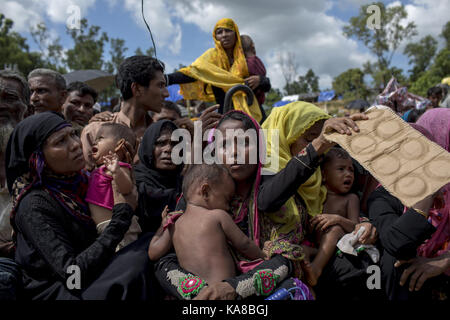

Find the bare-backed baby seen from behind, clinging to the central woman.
[{"left": 148, "top": 164, "right": 265, "bottom": 292}]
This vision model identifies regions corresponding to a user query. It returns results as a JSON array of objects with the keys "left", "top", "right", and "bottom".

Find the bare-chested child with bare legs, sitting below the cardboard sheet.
[{"left": 304, "top": 148, "right": 359, "bottom": 286}]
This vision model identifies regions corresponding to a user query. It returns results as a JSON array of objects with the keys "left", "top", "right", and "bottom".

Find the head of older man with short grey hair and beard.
[{"left": 28, "top": 69, "right": 67, "bottom": 113}]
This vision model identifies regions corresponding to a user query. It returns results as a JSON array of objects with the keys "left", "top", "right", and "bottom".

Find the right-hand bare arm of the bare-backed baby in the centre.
[{"left": 216, "top": 210, "right": 266, "bottom": 260}]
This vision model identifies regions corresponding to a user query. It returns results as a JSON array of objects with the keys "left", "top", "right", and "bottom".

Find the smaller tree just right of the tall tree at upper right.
[{"left": 404, "top": 35, "right": 437, "bottom": 82}]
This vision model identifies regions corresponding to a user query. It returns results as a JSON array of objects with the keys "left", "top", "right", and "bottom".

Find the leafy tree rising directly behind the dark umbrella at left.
[{"left": 65, "top": 19, "right": 108, "bottom": 70}]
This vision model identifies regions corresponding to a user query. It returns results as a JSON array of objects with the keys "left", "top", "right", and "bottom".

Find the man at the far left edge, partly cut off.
[{"left": 0, "top": 70, "right": 30, "bottom": 300}]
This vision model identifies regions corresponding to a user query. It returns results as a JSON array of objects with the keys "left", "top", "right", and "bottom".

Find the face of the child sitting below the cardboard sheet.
[{"left": 323, "top": 158, "right": 355, "bottom": 194}]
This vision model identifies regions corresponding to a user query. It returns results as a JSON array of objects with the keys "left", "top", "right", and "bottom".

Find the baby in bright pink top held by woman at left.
[{"left": 85, "top": 123, "right": 141, "bottom": 251}]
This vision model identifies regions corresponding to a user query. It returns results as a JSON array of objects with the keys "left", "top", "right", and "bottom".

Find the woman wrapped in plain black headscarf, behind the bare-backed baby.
[{"left": 134, "top": 120, "right": 183, "bottom": 232}]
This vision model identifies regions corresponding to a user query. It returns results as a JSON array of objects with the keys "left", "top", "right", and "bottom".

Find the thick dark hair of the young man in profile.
[{"left": 116, "top": 56, "right": 164, "bottom": 101}]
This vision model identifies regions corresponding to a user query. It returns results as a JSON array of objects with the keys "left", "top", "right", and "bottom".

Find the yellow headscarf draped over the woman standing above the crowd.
[{"left": 179, "top": 18, "right": 262, "bottom": 122}]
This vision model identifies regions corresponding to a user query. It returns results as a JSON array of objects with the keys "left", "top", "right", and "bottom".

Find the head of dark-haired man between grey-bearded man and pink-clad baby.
[{"left": 62, "top": 81, "right": 97, "bottom": 135}]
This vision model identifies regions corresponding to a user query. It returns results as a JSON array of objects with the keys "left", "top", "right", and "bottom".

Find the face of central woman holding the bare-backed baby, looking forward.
[{"left": 218, "top": 119, "right": 258, "bottom": 182}]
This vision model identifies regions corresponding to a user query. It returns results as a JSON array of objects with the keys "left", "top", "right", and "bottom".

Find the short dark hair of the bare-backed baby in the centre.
[{"left": 183, "top": 163, "right": 231, "bottom": 201}]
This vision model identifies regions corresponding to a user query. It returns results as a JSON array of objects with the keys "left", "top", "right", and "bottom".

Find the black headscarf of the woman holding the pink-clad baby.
[{"left": 6, "top": 111, "right": 93, "bottom": 228}]
